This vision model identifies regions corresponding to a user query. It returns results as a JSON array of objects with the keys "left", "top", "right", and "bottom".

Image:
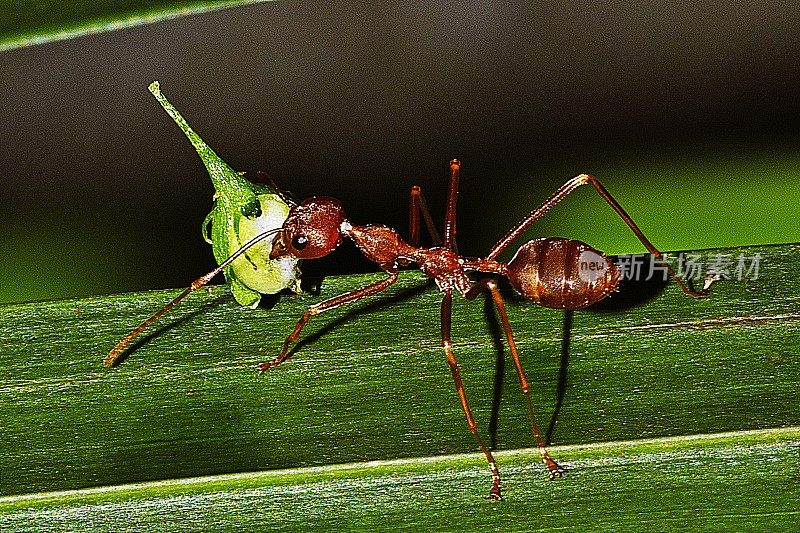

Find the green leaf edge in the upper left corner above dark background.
[{"left": 0, "top": 0, "right": 276, "bottom": 51}]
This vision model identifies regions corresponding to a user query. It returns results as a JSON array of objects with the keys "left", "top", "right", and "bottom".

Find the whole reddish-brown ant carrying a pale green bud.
[{"left": 105, "top": 160, "right": 710, "bottom": 500}]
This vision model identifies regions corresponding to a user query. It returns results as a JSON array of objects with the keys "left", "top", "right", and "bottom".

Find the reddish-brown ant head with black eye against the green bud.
[{"left": 270, "top": 196, "right": 345, "bottom": 259}]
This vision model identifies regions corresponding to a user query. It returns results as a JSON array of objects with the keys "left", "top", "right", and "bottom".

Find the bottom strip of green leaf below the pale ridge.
[{"left": 0, "top": 428, "right": 800, "bottom": 531}]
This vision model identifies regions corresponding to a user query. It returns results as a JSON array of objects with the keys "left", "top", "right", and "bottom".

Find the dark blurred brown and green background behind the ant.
[{"left": 0, "top": 1, "right": 800, "bottom": 302}]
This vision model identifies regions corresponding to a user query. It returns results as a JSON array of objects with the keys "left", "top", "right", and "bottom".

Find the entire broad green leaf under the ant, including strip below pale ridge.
[{"left": 0, "top": 245, "right": 800, "bottom": 531}]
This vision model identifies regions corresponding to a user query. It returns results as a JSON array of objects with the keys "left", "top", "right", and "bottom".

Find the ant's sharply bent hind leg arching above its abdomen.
[{"left": 486, "top": 174, "right": 713, "bottom": 298}]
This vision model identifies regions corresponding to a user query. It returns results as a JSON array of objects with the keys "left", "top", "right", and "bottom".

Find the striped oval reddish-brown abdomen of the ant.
[{"left": 507, "top": 237, "right": 620, "bottom": 309}]
